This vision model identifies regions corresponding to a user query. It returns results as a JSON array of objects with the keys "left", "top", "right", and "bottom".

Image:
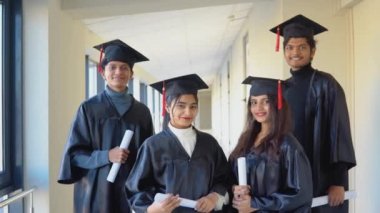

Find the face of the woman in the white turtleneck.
[{"left": 166, "top": 94, "right": 198, "bottom": 129}]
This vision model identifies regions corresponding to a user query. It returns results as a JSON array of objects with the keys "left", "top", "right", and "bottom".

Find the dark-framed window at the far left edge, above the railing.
[{"left": 0, "top": 0, "right": 23, "bottom": 196}]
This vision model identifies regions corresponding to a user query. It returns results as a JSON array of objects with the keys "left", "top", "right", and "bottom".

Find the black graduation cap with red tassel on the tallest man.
[{"left": 270, "top": 14, "right": 327, "bottom": 51}]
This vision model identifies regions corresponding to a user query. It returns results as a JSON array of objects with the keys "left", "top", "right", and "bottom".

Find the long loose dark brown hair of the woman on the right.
[{"left": 229, "top": 95, "right": 291, "bottom": 159}]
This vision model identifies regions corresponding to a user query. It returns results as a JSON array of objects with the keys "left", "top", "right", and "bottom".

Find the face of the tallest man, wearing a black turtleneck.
[{"left": 284, "top": 38, "right": 315, "bottom": 71}]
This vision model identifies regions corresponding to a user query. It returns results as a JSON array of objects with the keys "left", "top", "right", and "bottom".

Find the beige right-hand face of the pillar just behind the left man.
[{"left": 47, "top": 0, "right": 86, "bottom": 212}]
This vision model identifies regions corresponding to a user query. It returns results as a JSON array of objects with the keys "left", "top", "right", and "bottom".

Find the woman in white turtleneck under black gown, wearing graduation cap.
[{"left": 127, "top": 74, "right": 229, "bottom": 213}]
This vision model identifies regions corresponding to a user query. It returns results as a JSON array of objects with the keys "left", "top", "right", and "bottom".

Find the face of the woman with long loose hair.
[{"left": 250, "top": 95, "right": 270, "bottom": 124}]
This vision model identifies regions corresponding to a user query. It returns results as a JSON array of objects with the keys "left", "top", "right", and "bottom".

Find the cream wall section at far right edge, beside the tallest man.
[{"left": 353, "top": 0, "right": 380, "bottom": 212}]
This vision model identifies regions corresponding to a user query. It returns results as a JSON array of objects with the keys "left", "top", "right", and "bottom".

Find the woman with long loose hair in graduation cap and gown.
[{"left": 229, "top": 77, "right": 312, "bottom": 212}]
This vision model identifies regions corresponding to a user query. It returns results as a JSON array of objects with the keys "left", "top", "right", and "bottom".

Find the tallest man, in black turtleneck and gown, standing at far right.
[{"left": 270, "top": 14, "right": 356, "bottom": 213}]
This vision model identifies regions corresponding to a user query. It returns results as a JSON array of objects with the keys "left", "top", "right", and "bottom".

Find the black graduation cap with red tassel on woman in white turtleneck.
[{"left": 150, "top": 74, "right": 208, "bottom": 116}]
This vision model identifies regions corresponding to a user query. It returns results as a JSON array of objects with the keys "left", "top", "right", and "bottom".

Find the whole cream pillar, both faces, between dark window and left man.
[{"left": 23, "top": 0, "right": 85, "bottom": 213}]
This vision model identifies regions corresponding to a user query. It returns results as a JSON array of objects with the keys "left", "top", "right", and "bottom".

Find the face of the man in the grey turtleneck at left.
[{"left": 102, "top": 61, "right": 133, "bottom": 92}]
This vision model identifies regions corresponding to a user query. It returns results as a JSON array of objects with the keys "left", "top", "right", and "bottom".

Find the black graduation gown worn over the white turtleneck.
[{"left": 127, "top": 129, "right": 229, "bottom": 213}]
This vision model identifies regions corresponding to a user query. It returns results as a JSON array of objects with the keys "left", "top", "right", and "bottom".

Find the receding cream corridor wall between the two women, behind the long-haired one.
[{"left": 212, "top": 1, "right": 283, "bottom": 156}]
